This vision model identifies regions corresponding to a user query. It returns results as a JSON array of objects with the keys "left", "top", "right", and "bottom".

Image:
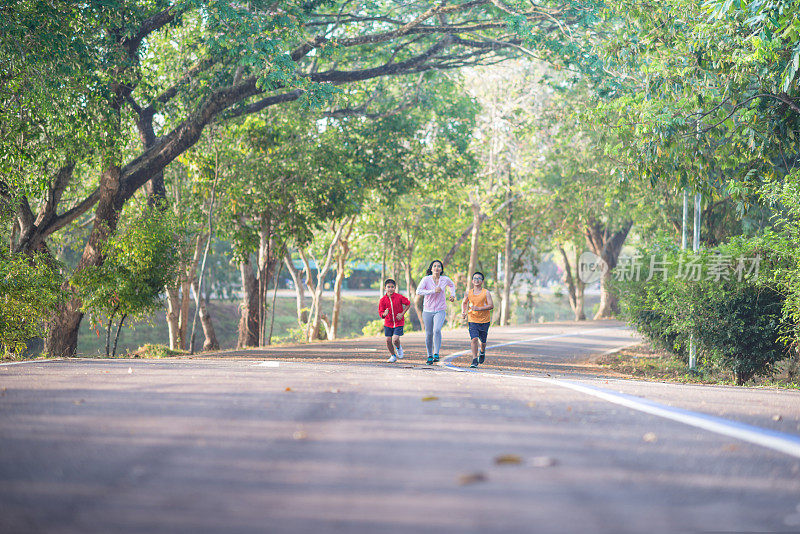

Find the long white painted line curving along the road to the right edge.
[{"left": 443, "top": 328, "right": 800, "bottom": 458}]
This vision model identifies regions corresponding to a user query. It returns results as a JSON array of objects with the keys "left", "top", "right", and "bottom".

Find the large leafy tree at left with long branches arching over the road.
[{"left": 0, "top": 0, "right": 591, "bottom": 355}]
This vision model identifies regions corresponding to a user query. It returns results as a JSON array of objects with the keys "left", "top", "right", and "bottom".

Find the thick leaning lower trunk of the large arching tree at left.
[{"left": 44, "top": 166, "right": 120, "bottom": 357}]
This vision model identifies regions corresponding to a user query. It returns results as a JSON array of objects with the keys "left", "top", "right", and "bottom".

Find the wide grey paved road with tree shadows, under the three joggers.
[{"left": 0, "top": 323, "right": 800, "bottom": 533}]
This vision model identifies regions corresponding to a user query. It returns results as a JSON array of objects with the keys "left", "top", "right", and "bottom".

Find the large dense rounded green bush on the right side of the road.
[{"left": 614, "top": 235, "right": 789, "bottom": 384}]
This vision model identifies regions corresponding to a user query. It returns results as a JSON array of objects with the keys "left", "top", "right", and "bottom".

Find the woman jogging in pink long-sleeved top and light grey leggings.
[{"left": 417, "top": 260, "right": 456, "bottom": 365}]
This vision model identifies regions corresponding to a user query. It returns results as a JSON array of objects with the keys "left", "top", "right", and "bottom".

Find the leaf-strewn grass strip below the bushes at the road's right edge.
[{"left": 594, "top": 343, "right": 800, "bottom": 389}]
